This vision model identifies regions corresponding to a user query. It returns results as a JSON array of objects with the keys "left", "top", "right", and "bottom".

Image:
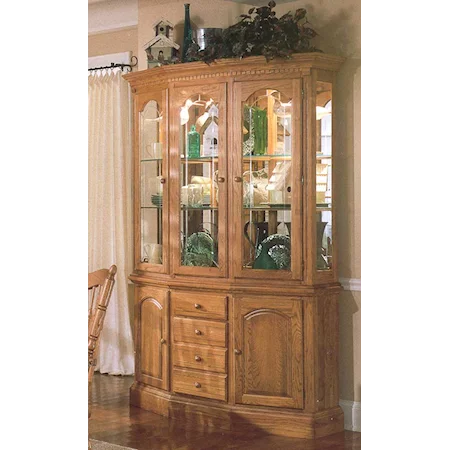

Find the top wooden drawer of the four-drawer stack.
[{"left": 171, "top": 292, "right": 227, "bottom": 320}]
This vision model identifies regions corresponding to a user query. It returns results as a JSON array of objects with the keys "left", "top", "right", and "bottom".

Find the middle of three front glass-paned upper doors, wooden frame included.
[{"left": 172, "top": 84, "right": 227, "bottom": 276}]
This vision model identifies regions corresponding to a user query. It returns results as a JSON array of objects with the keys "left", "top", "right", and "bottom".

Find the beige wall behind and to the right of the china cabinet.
[{"left": 88, "top": 0, "right": 362, "bottom": 401}]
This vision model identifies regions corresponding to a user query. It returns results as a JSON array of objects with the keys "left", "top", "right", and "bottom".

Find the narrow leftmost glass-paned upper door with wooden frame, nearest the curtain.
[{"left": 134, "top": 89, "right": 169, "bottom": 273}]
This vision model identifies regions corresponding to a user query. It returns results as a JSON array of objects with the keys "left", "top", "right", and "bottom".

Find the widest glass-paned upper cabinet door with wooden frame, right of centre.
[{"left": 233, "top": 80, "right": 302, "bottom": 279}]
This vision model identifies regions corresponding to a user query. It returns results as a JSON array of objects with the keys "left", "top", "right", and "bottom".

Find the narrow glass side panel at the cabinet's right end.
[{"left": 316, "top": 81, "right": 333, "bottom": 271}]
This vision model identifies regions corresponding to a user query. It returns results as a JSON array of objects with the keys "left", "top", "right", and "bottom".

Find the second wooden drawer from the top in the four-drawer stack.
[{"left": 172, "top": 317, "right": 227, "bottom": 347}]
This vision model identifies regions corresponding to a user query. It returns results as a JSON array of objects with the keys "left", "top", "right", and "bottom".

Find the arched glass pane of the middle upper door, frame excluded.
[{"left": 179, "top": 95, "right": 221, "bottom": 267}]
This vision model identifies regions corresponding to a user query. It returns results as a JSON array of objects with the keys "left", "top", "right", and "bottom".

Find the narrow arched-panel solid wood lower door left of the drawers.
[{"left": 135, "top": 287, "right": 169, "bottom": 390}]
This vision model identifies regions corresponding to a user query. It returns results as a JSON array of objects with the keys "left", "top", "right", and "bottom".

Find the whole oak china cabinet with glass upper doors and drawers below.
[{"left": 124, "top": 53, "right": 343, "bottom": 438}]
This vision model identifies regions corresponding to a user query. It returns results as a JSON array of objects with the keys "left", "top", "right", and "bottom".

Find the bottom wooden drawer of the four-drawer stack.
[{"left": 172, "top": 369, "right": 227, "bottom": 401}]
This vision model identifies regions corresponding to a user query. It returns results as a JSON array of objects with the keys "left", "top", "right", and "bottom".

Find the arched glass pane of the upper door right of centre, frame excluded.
[{"left": 241, "top": 89, "right": 292, "bottom": 271}]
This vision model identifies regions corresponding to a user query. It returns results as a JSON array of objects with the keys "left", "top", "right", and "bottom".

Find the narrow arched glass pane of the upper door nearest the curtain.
[{"left": 140, "top": 100, "right": 163, "bottom": 264}]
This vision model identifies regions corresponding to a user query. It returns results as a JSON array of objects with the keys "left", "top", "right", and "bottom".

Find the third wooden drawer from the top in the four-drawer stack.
[{"left": 172, "top": 344, "right": 227, "bottom": 373}]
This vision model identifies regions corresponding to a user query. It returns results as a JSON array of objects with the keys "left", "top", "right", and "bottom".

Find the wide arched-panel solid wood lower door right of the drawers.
[{"left": 234, "top": 297, "right": 303, "bottom": 408}]
